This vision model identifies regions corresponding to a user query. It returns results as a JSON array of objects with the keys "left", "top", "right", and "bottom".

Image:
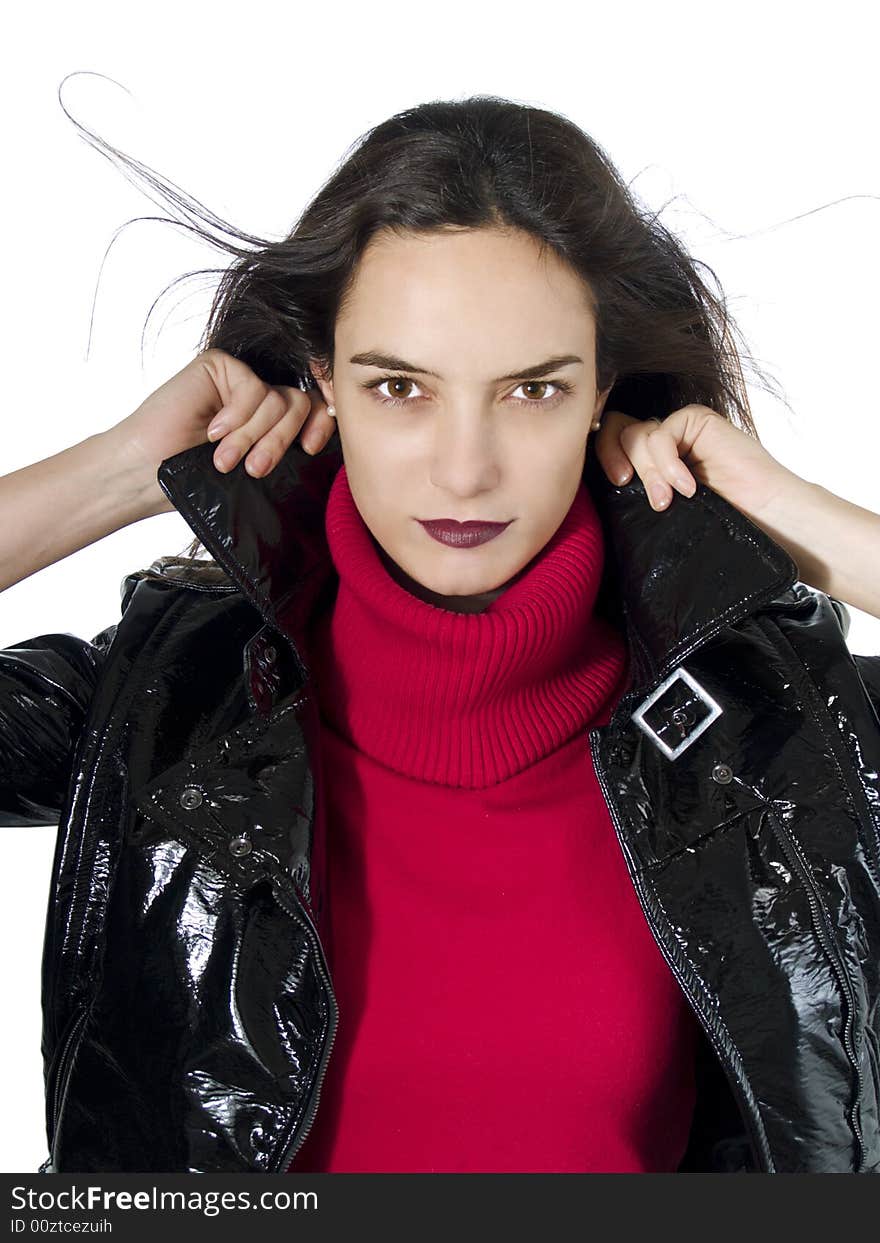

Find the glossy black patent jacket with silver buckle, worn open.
[{"left": 0, "top": 438, "right": 880, "bottom": 1173}]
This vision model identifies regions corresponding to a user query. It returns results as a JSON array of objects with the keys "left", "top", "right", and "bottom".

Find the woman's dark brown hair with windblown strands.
[{"left": 65, "top": 75, "right": 777, "bottom": 554}]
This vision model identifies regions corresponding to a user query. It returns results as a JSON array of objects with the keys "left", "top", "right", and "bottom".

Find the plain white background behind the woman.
[{"left": 0, "top": 0, "right": 880, "bottom": 1171}]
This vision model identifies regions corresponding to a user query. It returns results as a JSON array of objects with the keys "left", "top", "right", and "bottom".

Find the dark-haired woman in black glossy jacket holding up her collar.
[{"left": 0, "top": 97, "right": 880, "bottom": 1172}]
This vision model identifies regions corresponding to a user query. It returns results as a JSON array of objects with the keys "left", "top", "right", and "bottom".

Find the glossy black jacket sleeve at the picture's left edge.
[{"left": 0, "top": 625, "right": 116, "bottom": 825}]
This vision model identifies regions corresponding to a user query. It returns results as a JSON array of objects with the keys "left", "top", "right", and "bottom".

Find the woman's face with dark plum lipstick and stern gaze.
[{"left": 312, "top": 229, "right": 609, "bottom": 612}]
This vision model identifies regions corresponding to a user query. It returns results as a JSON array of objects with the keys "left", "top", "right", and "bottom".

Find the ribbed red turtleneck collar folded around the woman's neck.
[{"left": 312, "top": 466, "right": 628, "bottom": 789}]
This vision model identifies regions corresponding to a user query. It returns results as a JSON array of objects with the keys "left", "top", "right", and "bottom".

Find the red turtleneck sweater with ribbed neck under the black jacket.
[{"left": 290, "top": 466, "right": 697, "bottom": 1172}]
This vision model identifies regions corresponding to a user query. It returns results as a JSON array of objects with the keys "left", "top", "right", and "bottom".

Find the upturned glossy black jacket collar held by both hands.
[{"left": 157, "top": 434, "right": 798, "bottom": 690}]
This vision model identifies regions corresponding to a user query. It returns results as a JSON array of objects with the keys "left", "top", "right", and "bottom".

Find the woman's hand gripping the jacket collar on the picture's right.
[{"left": 594, "top": 405, "right": 798, "bottom": 522}]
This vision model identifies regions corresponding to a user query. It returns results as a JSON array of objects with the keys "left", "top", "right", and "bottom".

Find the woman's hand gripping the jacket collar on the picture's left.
[{"left": 107, "top": 349, "right": 336, "bottom": 515}]
